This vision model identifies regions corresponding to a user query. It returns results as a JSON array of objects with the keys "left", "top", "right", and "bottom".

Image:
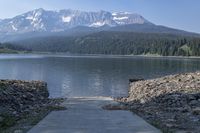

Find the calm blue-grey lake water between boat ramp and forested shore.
[{"left": 0, "top": 55, "right": 200, "bottom": 97}]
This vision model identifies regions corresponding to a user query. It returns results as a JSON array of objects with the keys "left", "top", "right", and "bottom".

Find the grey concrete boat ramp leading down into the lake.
[{"left": 28, "top": 97, "right": 160, "bottom": 133}]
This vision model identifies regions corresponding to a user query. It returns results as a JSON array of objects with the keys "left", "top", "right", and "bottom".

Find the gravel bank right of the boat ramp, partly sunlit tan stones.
[{"left": 116, "top": 72, "right": 200, "bottom": 133}]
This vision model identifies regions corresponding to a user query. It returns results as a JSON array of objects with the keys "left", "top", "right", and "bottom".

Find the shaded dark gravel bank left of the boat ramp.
[{"left": 0, "top": 80, "right": 63, "bottom": 133}]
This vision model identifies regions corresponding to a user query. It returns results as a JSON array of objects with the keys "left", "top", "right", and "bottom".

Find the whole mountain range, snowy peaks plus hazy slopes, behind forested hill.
[{"left": 0, "top": 8, "right": 198, "bottom": 42}]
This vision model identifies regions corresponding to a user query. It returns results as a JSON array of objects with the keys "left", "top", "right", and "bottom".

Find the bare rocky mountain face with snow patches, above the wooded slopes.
[{"left": 0, "top": 8, "right": 150, "bottom": 34}]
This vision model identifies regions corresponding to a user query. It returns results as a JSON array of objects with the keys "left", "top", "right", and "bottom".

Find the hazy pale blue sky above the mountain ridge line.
[{"left": 0, "top": 0, "right": 200, "bottom": 33}]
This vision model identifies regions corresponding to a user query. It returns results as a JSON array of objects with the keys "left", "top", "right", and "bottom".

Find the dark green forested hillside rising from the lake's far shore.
[{"left": 3, "top": 31, "right": 200, "bottom": 56}]
